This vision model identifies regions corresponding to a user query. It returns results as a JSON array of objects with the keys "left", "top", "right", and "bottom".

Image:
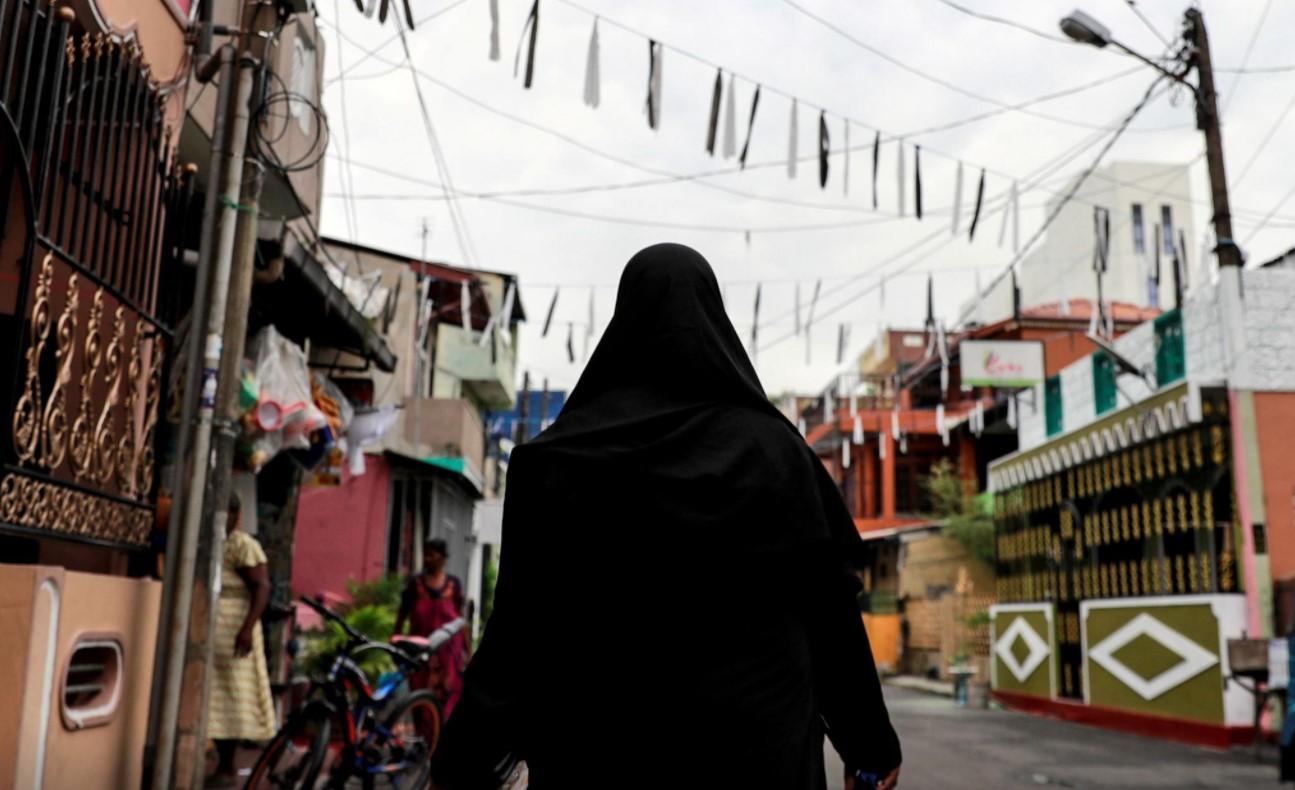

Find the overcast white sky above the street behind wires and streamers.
[{"left": 310, "top": 0, "right": 1295, "bottom": 392}]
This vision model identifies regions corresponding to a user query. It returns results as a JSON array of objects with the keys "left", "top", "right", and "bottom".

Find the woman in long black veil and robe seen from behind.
[{"left": 433, "top": 245, "right": 900, "bottom": 790}]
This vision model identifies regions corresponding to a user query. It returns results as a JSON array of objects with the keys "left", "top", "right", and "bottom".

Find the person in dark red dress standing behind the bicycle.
[{"left": 395, "top": 537, "right": 466, "bottom": 719}]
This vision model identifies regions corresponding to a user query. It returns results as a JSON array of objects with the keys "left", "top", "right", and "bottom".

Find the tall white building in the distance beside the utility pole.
[{"left": 965, "top": 162, "right": 1206, "bottom": 324}]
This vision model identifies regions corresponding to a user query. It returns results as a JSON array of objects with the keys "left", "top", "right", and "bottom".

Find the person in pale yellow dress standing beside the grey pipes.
[{"left": 207, "top": 495, "right": 275, "bottom": 787}]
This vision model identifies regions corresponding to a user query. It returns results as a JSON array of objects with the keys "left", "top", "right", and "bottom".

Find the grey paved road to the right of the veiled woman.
[{"left": 828, "top": 686, "right": 1279, "bottom": 790}]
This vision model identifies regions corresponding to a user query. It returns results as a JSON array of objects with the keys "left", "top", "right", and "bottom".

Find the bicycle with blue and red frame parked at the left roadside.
[{"left": 245, "top": 598, "right": 465, "bottom": 790}]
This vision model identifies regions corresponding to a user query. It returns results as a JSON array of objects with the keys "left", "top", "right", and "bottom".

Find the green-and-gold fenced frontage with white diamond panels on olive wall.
[{"left": 991, "top": 382, "right": 1261, "bottom": 746}]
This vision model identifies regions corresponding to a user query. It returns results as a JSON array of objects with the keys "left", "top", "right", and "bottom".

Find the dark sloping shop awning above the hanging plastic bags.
[{"left": 253, "top": 233, "right": 396, "bottom": 373}]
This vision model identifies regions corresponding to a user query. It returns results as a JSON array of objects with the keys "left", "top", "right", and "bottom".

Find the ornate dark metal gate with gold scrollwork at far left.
[{"left": 0, "top": 0, "right": 182, "bottom": 547}]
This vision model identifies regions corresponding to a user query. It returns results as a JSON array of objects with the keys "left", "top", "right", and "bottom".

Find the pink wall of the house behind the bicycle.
[{"left": 293, "top": 456, "right": 391, "bottom": 596}]
